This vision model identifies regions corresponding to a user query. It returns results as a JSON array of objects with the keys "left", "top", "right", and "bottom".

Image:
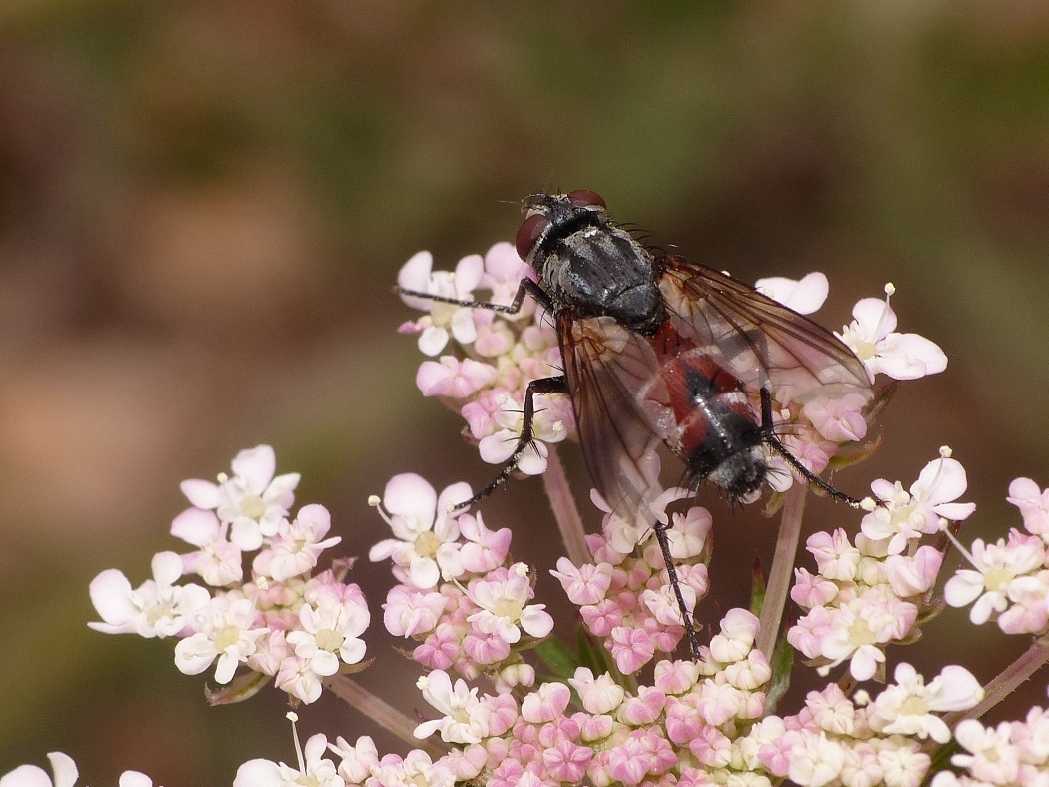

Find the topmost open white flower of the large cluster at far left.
[{"left": 180, "top": 445, "right": 300, "bottom": 551}]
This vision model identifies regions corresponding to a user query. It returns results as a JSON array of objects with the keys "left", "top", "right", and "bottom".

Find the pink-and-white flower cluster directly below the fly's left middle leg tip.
[{"left": 369, "top": 473, "right": 554, "bottom": 684}]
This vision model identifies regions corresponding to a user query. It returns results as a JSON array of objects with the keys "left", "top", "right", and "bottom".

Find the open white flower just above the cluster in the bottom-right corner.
[{"left": 871, "top": 663, "right": 983, "bottom": 743}]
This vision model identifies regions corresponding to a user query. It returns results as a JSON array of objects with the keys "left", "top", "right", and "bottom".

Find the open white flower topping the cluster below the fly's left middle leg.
[{"left": 368, "top": 473, "right": 471, "bottom": 589}]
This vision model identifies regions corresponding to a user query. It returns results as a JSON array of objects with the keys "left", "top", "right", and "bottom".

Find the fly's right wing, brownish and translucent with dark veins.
[{"left": 660, "top": 256, "right": 872, "bottom": 404}]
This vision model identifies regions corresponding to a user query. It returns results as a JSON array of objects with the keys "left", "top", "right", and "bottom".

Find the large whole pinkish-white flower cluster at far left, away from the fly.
[{"left": 88, "top": 445, "right": 370, "bottom": 702}]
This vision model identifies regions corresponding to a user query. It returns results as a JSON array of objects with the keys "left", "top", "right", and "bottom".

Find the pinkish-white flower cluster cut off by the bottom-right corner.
[{"left": 932, "top": 707, "right": 1049, "bottom": 787}]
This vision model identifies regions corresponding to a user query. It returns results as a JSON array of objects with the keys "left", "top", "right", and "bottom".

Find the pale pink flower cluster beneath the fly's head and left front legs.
[{"left": 398, "top": 242, "right": 575, "bottom": 475}]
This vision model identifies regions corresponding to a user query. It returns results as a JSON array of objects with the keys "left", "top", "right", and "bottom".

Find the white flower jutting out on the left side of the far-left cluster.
[{"left": 88, "top": 552, "right": 210, "bottom": 638}]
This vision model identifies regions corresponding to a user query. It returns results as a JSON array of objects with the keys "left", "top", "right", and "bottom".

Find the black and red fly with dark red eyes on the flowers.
[{"left": 400, "top": 190, "right": 873, "bottom": 658}]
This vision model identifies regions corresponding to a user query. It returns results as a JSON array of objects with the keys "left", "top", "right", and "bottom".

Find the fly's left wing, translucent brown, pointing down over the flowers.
[{"left": 558, "top": 315, "right": 672, "bottom": 522}]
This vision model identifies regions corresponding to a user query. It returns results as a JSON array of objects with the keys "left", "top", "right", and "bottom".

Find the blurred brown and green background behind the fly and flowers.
[{"left": 0, "top": 0, "right": 1049, "bottom": 787}]
